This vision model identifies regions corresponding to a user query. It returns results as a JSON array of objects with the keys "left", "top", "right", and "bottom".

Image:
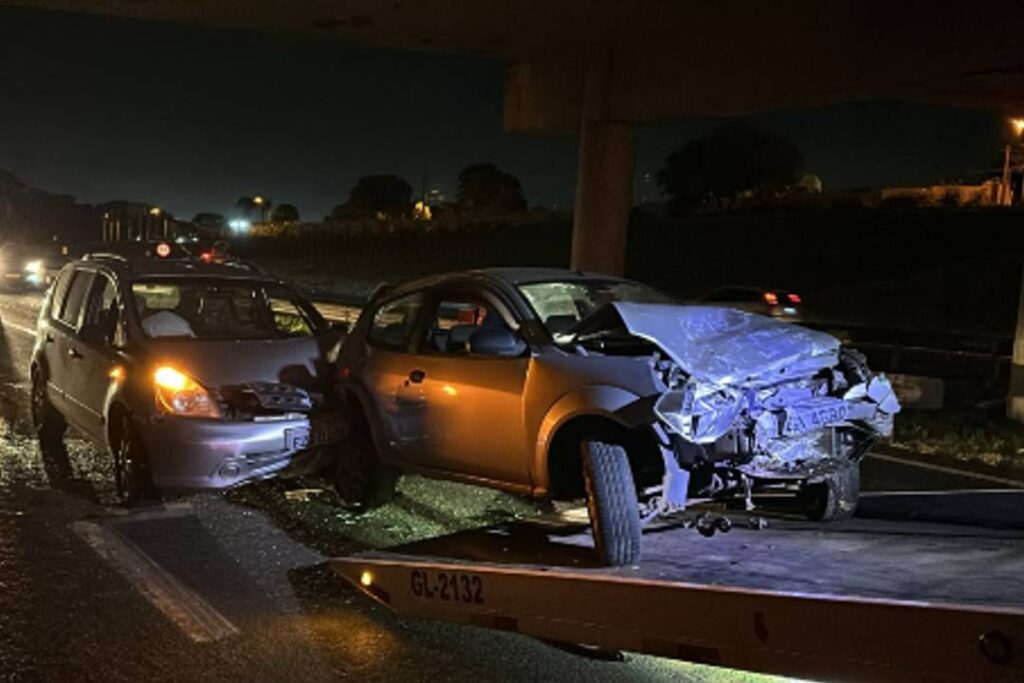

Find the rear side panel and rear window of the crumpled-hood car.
[{"left": 360, "top": 292, "right": 424, "bottom": 462}]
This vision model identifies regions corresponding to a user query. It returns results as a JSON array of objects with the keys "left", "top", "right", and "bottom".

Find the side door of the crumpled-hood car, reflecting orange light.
[{"left": 400, "top": 290, "right": 530, "bottom": 486}]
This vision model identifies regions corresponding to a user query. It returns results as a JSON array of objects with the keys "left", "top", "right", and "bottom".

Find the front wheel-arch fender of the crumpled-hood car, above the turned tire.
[{"left": 530, "top": 384, "right": 643, "bottom": 494}]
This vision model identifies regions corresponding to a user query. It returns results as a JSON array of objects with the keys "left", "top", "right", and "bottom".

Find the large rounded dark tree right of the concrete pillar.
[{"left": 657, "top": 124, "right": 804, "bottom": 215}]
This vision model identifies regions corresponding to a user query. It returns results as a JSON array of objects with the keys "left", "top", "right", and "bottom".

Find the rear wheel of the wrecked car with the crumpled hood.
[{"left": 334, "top": 433, "right": 398, "bottom": 511}]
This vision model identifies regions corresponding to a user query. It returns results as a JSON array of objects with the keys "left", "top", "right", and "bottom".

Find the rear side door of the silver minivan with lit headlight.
[{"left": 44, "top": 268, "right": 93, "bottom": 427}]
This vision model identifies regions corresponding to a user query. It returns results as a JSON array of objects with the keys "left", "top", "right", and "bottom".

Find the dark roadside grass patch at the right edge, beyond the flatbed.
[{"left": 892, "top": 409, "right": 1024, "bottom": 472}]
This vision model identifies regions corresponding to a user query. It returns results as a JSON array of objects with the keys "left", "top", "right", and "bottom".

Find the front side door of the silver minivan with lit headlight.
[{"left": 66, "top": 272, "right": 121, "bottom": 440}]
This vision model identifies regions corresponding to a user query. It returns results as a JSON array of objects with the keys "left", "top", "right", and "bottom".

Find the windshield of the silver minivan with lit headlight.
[{"left": 131, "top": 279, "right": 324, "bottom": 340}]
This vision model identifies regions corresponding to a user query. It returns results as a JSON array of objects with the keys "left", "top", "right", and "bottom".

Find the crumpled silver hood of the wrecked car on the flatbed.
[{"left": 611, "top": 302, "right": 840, "bottom": 385}]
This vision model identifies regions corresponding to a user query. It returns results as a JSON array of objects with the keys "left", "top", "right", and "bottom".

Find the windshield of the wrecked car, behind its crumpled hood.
[{"left": 519, "top": 280, "right": 675, "bottom": 337}]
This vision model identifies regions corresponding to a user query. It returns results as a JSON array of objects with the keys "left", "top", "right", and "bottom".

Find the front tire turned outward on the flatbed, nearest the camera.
[{"left": 582, "top": 441, "right": 641, "bottom": 566}]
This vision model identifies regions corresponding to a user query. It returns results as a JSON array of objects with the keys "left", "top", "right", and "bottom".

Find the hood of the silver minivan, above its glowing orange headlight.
[{"left": 146, "top": 337, "right": 330, "bottom": 390}]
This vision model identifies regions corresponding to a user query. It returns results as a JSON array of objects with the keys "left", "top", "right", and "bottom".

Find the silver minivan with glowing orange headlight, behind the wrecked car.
[{"left": 31, "top": 244, "right": 344, "bottom": 504}]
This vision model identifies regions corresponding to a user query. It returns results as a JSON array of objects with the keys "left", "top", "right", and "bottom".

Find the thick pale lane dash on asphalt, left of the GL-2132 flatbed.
[{"left": 71, "top": 521, "right": 242, "bottom": 643}]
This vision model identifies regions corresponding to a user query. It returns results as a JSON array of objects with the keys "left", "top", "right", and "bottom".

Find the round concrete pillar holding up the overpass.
[{"left": 571, "top": 51, "right": 633, "bottom": 275}]
